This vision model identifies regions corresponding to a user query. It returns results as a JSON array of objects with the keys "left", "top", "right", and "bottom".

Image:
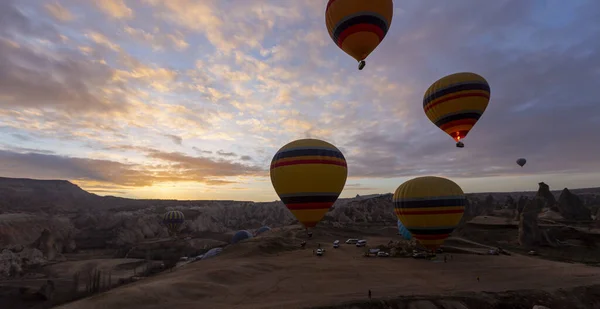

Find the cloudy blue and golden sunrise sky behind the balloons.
[{"left": 0, "top": 0, "right": 600, "bottom": 201}]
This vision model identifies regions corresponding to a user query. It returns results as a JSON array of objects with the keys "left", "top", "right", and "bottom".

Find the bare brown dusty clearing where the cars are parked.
[{"left": 52, "top": 225, "right": 600, "bottom": 309}]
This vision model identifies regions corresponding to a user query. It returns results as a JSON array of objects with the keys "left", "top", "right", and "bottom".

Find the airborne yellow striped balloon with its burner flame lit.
[{"left": 423, "top": 72, "right": 490, "bottom": 148}]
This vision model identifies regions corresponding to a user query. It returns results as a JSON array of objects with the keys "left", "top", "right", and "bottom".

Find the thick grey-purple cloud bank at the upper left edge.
[{"left": 0, "top": 26, "right": 127, "bottom": 111}]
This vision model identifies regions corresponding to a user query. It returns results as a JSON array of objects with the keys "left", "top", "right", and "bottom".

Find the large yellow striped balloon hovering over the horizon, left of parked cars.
[{"left": 271, "top": 139, "right": 348, "bottom": 232}]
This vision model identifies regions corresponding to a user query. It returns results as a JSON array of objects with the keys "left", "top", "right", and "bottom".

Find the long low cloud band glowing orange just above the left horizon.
[{"left": 0, "top": 149, "right": 264, "bottom": 187}]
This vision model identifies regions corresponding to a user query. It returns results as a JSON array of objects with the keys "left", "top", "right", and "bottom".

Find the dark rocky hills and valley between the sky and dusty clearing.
[{"left": 0, "top": 178, "right": 600, "bottom": 308}]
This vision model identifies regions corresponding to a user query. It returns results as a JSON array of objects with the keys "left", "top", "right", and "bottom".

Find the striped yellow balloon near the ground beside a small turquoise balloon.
[{"left": 394, "top": 176, "right": 466, "bottom": 250}]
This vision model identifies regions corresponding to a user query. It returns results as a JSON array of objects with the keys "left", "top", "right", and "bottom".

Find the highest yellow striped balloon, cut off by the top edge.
[{"left": 325, "top": 0, "right": 394, "bottom": 70}]
